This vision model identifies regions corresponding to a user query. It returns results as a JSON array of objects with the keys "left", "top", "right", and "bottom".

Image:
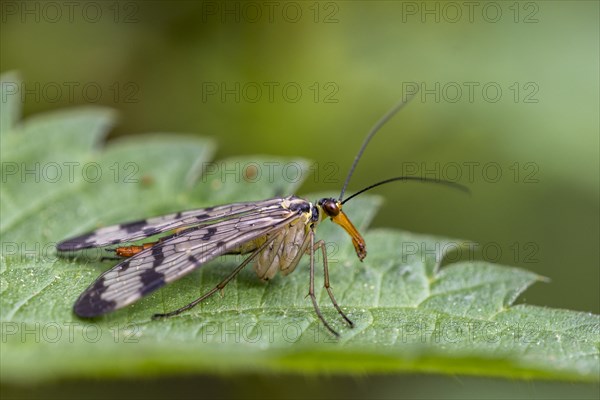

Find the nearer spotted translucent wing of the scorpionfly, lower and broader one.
[{"left": 74, "top": 205, "right": 300, "bottom": 317}]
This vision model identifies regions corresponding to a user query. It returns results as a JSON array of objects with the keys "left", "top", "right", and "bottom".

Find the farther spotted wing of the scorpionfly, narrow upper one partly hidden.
[{"left": 56, "top": 198, "right": 283, "bottom": 252}]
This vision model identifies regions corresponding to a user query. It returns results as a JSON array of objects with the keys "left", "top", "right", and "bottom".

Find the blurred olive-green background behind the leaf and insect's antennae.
[{"left": 0, "top": 1, "right": 600, "bottom": 397}]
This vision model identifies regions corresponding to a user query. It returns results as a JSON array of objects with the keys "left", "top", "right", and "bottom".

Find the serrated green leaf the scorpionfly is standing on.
[{"left": 0, "top": 74, "right": 600, "bottom": 382}]
